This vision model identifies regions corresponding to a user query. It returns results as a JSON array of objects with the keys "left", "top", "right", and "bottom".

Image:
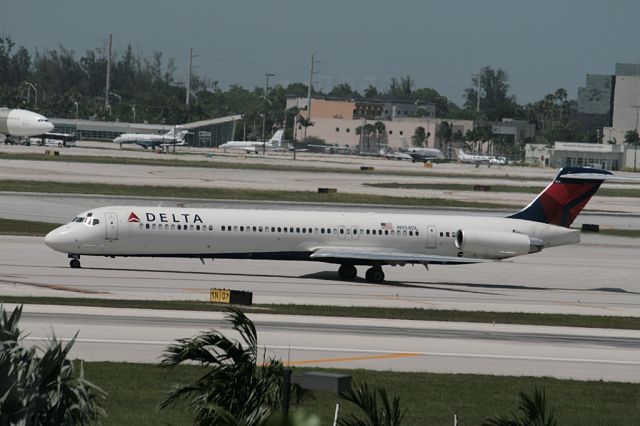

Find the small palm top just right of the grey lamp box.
[{"left": 338, "top": 383, "right": 407, "bottom": 426}]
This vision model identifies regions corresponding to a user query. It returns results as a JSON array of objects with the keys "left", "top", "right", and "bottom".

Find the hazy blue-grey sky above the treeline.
[{"left": 0, "top": 0, "right": 640, "bottom": 104}]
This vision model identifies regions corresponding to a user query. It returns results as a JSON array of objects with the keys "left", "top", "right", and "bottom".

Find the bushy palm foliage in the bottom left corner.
[{"left": 0, "top": 306, "right": 104, "bottom": 426}]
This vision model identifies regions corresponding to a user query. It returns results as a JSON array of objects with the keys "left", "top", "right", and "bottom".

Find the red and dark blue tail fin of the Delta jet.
[{"left": 507, "top": 167, "right": 613, "bottom": 228}]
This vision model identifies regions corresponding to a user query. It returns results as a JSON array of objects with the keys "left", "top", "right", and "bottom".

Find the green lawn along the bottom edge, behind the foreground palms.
[{"left": 89, "top": 362, "right": 640, "bottom": 426}]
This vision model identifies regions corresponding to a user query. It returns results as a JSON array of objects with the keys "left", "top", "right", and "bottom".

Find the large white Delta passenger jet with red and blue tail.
[{"left": 44, "top": 167, "right": 623, "bottom": 283}]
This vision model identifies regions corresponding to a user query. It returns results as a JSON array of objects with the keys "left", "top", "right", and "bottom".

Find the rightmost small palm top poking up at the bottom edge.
[{"left": 482, "top": 388, "right": 557, "bottom": 426}]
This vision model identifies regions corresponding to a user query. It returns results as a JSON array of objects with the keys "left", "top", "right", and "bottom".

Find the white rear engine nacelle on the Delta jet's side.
[{"left": 456, "top": 229, "right": 544, "bottom": 259}]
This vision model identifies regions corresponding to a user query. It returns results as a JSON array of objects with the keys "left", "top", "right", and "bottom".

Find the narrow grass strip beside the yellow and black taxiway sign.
[{"left": 0, "top": 296, "right": 640, "bottom": 330}]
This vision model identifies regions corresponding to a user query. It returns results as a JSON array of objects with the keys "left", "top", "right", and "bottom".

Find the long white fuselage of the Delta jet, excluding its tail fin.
[{"left": 45, "top": 207, "right": 579, "bottom": 264}]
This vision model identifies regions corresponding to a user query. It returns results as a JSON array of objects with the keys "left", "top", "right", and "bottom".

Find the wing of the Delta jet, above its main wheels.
[{"left": 310, "top": 247, "right": 492, "bottom": 265}]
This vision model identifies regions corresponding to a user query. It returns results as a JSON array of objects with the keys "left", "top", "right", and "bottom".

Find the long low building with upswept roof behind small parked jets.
[{"left": 50, "top": 115, "right": 241, "bottom": 148}]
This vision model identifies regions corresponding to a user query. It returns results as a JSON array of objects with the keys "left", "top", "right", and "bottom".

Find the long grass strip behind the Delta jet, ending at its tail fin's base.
[{"left": 0, "top": 180, "right": 521, "bottom": 209}]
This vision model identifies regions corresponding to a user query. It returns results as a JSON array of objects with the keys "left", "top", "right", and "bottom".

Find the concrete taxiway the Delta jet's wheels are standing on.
[{"left": 0, "top": 235, "right": 640, "bottom": 316}]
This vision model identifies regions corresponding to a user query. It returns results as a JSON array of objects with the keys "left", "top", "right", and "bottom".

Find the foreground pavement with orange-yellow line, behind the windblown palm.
[{"left": 13, "top": 305, "right": 640, "bottom": 382}]
